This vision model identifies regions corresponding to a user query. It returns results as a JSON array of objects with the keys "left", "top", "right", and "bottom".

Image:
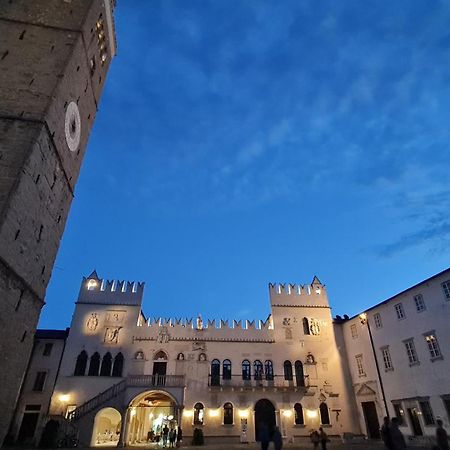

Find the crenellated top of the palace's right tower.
[{"left": 269, "top": 276, "right": 328, "bottom": 306}]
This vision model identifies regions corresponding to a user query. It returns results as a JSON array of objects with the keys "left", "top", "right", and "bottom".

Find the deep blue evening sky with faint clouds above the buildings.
[{"left": 40, "top": 0, "right": 450, "bottom": 328}]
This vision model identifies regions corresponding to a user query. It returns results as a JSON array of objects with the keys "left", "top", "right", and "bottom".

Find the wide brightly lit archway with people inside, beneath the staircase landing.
[{"left": 127, "top": 390, "right": 180, "bottom": 446}]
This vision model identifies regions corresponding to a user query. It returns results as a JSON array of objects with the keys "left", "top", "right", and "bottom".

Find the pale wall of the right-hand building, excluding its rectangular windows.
[{"left": 342, "top": 270, "right": 450, "bottom": 436}]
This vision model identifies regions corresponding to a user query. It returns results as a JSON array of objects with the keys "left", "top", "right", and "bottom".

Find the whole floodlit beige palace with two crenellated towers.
[{"left": 50, "top": 272, "right": 358, "bottom": 445}]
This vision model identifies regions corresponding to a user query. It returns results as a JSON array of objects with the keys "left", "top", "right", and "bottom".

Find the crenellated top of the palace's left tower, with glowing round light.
[{"left": 78, "top": 270, "right": 145, "bottom": 306}]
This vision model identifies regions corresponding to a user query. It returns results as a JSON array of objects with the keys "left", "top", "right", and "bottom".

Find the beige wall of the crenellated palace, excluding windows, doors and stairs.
[{"left": 50, "top": 272, "right": 359, "bottom": 441}]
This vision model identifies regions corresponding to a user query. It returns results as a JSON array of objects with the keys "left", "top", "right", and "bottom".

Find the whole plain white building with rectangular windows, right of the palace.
[{"left": 342, "top": 269, "right": 450, "bottom": 440}]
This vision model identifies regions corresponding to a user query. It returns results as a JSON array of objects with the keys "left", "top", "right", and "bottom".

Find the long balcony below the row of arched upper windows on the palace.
[{"left": 208, "top": 375, "right": 313, "bottom": 392}]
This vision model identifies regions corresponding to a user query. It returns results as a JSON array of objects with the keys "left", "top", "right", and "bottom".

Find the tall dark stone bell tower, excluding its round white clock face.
[{"left": 0, "top": 0, "right": 116, "bottom": 444}]
